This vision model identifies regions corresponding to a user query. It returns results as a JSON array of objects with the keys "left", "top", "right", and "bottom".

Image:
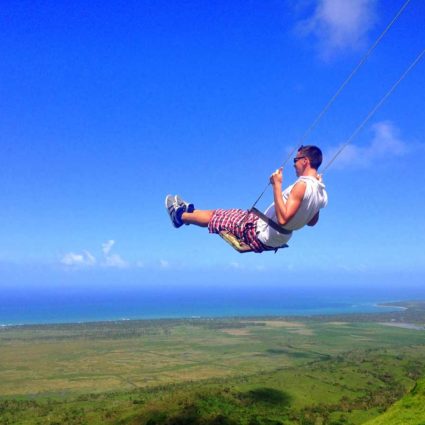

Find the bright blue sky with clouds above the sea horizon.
[{"left": 0, "top": 0, "right": 425, "bottom": 286}]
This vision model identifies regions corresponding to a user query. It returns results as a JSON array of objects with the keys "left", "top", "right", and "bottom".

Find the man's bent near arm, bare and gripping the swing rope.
[{"left": 270, "top": 169, "right": 306, "bottom": 226}]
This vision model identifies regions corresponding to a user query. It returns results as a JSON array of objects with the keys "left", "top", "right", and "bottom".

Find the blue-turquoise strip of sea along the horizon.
[{"left": 0, "top": 285, "right": 425, "bottom": 326}]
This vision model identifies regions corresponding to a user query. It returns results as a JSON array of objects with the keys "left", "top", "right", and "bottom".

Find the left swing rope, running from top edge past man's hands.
[{"left": 250, "top": 0, "right": 411, "bottom": 210}]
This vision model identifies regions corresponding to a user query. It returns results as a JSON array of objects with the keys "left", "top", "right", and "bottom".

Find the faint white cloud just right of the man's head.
[{"left": 327, "top": 121, "right": 409, "bottom": 168}]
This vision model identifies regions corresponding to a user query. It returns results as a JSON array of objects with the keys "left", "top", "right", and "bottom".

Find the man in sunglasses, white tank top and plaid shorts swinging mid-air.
[{"left": 165, "top": 145, "right": 328, "bottom": 253}]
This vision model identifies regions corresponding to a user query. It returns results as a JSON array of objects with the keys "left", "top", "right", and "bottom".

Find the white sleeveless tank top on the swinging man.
[{"left": 257, "top": 176, "right": 328, "bottom": 247}]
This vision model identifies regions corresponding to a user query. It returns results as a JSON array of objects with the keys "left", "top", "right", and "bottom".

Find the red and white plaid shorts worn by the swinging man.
[{"left": 208, "top": 209, "right": 265, "bottom": 252}]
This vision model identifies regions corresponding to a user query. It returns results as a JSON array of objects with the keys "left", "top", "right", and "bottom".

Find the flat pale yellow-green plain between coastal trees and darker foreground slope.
[{"left": 0, "top": 319, "right": 425, "bottom": 396}]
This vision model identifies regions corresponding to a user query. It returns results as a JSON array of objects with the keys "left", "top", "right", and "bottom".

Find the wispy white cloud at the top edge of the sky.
[{"left": 297, "top": 0, "right": 376, "bottom": 59}]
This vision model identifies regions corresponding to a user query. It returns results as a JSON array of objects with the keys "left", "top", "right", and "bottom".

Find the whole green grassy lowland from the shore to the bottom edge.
[{"left": 0, "top": 304, "right": 425, "bottom": 425}]
